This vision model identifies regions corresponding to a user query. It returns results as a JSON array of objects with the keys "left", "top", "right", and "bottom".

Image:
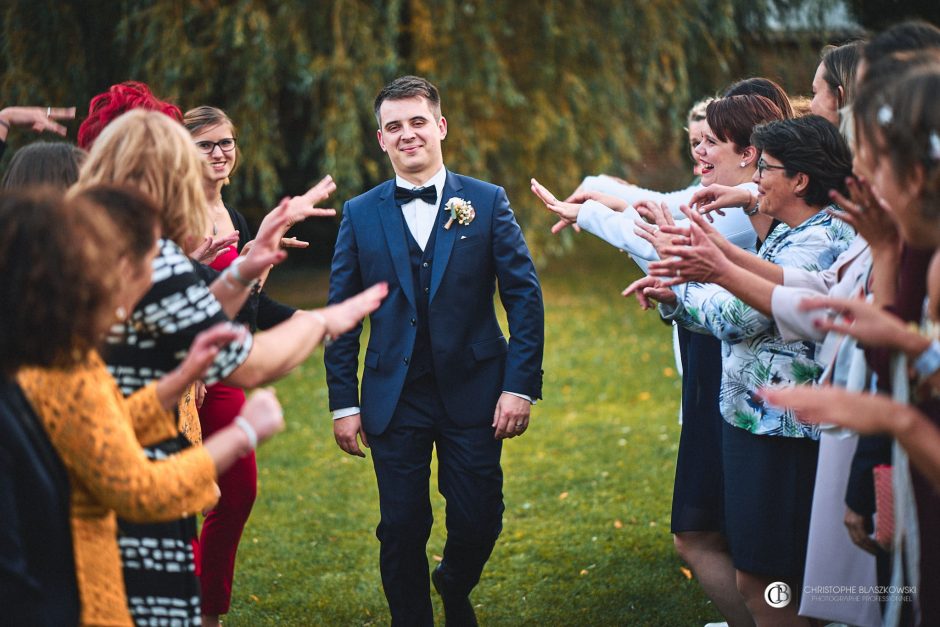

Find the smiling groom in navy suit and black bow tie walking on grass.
[{"left": 325, "top": 76, "right": 544, "bottom": 626}]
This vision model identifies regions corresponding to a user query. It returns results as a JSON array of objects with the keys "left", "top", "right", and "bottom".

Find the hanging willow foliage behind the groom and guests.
[{"left": 0, "top": 0, "right": 852, "bottom": 257}]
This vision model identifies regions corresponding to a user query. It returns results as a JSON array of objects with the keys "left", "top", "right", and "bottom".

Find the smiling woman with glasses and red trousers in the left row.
[{"left": 183, "top": 106, "right": 302, "bottom": 627}]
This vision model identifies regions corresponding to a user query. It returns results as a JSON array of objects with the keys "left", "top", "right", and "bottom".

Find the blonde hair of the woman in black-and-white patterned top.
[{"left": 76, "top": 109, "right": 207, "bottom": 252}]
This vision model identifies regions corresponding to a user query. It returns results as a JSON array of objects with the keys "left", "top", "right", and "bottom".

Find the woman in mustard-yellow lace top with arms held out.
[{"left": 10, "top": 186, "right": 283, "bottom": 625}]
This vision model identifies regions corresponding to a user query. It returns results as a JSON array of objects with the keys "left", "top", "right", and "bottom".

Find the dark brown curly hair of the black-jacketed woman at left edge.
[{"left": 0, "top": 188, "right": 119, "bottom": 375}]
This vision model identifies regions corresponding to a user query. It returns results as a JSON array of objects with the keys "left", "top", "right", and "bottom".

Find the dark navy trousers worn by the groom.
[{"left": 367, "top": 374, "right": 504, "bottom": 627}]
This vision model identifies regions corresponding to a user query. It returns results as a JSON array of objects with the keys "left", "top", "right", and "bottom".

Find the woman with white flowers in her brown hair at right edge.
[{"left": 774, "top": 66, "right": 940, "bottom": 624}]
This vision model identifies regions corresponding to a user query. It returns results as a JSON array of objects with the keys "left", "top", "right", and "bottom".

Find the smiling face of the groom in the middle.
[{"left": 377, "top": 96, "right": 447, "bottom": 185}]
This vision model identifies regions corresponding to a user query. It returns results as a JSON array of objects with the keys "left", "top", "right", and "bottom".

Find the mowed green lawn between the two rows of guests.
[{"left": 225, "top": 235, "right": 718, "bottom": 626}]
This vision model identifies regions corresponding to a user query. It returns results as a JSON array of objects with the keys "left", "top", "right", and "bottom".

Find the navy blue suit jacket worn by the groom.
[{"left": 325, "top": 171, "right": 545, "bottom": 434}]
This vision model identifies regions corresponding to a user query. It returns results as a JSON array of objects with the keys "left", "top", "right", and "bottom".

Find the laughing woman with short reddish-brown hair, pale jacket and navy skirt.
[{"left": 533, "top": 96, "right": 783, "bottom": 625}]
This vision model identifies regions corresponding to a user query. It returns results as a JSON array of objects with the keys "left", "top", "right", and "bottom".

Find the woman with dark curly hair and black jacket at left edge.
[{"left": 0, "top": 192, "right": 80, "bottom": 627}]
